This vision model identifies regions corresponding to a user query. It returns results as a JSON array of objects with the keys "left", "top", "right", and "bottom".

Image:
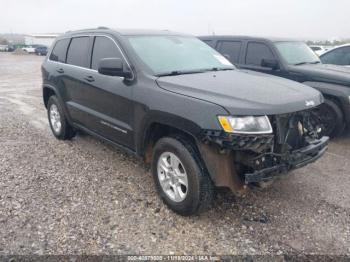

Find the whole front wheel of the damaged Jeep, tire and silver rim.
[{"left": 152, "top": 137, "right": 214, "bottom": 216}]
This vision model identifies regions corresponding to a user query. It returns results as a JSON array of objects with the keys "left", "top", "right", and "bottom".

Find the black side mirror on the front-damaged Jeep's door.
[{"left": 98, "top": 58, "right": 131, "bottom": 77}]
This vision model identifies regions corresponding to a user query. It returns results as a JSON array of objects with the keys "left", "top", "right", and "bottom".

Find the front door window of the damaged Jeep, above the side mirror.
[{"left": 91, "top": 36, "right": 122, "bottom": 70}]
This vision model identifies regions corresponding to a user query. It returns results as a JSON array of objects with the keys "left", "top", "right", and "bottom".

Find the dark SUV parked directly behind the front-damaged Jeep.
[{"left": 200, "top": 36, "right": 350, "bottom": 137}]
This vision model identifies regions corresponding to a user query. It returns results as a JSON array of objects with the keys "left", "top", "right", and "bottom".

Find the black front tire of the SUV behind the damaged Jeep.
[{"left": 316, "top": 99, "right": 345, "bottom": 137}]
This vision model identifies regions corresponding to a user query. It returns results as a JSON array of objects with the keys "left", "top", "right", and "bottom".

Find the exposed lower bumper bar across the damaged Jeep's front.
[{"left": 244, "top": 137, "right": 329, "bottom": 184}]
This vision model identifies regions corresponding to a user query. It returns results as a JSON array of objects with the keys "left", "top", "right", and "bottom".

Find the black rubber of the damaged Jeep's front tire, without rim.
[{"left": 152, "top": 137, "right": 214, "bottom": 216}]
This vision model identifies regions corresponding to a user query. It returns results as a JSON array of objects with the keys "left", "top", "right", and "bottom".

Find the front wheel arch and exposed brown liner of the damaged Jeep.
[{"left": 138, "top": 112, "right": 246, "bottom": 195}]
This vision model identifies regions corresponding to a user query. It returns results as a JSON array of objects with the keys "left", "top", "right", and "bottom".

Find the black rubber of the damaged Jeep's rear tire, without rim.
[{"left": 47, "top": 95, "right": 76, "bottom": 140}]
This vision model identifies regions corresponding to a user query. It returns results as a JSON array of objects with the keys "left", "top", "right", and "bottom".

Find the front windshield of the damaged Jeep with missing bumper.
[{"left": 128, "top": 35, "right": 234, "bottom": 75}]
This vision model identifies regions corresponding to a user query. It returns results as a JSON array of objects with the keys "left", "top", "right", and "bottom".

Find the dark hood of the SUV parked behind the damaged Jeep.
[{"left": 290, "top": 64, "right": 350, "bottom": 87}]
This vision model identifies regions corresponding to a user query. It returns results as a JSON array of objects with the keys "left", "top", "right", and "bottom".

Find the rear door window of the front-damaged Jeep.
[{"left": 67, "top": 36, "right": 90, "bottom": 68}]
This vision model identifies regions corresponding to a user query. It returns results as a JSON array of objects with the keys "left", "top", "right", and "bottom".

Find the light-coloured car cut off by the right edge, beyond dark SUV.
[{"left": 320, "top": 44, "right": 350, "bottom": 67}]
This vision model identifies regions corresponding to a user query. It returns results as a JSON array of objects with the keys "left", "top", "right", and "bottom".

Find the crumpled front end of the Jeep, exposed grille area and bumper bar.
[{"left": 202, "top": 107, "right": 329, "bottom": 189}]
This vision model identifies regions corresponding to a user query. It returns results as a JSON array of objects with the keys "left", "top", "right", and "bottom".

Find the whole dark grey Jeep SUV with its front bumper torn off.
[{"left": 42, "top": 29, "right": 328, "bottom": 215}]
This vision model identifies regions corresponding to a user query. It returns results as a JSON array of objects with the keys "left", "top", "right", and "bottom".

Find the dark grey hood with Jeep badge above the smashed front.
[{"left": 156, "top": 70, "right": 323, "bottom": 115}]
